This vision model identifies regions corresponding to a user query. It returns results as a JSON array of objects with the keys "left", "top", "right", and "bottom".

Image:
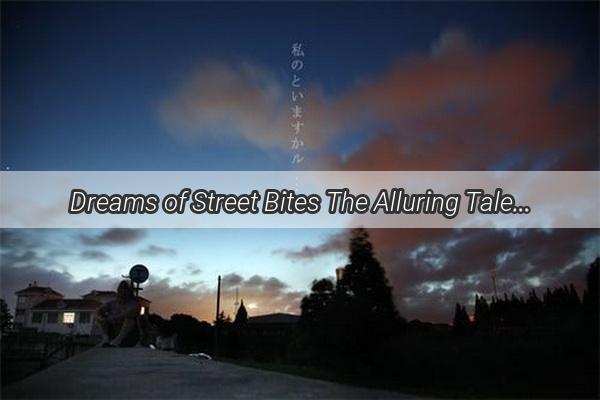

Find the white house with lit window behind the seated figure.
[{"left": 14, "top": 282, "right": 150, "bottom": 335}]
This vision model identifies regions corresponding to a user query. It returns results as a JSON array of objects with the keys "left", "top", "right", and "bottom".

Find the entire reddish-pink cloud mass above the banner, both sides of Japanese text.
[{"left": 160, "top": 27, "right": 599, "bottom": 170}]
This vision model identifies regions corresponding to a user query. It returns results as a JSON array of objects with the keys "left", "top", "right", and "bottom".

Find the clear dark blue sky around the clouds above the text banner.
[{"left": 1, "top": 2, "right": 598, "bottom": 170}]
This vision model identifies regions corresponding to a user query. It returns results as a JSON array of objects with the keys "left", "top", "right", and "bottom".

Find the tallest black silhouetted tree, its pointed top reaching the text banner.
[{"left": 301, "top": 228, "right": 404, "bottom": 368}]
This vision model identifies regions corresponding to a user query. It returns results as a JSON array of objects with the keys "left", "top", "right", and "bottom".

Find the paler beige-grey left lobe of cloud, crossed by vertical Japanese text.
[{"left": 160, "top": 61, "right": 338, "bottom": 149}]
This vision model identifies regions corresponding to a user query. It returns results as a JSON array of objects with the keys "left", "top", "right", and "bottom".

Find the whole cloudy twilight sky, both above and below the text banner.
[{"left": 0, "top": 2, "right": 600, "bottom": 321}]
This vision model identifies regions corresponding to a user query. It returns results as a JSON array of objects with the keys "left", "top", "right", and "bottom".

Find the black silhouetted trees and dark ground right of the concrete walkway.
[{"left": 144, "top": 229, "right": 600, "bottom": 397}]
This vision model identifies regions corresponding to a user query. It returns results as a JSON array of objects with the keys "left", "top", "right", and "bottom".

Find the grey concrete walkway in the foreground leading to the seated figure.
[{"left": 2, "top": 348, "right": 418, "bottom": 399}]
